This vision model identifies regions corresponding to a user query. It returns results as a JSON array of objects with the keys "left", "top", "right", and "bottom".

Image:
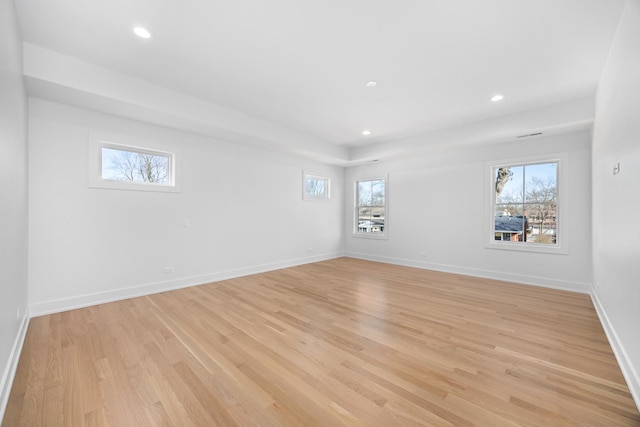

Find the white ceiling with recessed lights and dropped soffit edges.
[{"left": 16, "top": 0, "right": 625, "bottom": 163}]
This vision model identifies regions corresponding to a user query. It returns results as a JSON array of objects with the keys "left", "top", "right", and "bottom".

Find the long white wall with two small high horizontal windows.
[{"left": 29, "top": 98, "right": 343, "bottom": 314}]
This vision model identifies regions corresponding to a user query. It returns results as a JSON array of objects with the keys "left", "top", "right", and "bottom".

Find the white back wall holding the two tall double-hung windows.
[{"left": 344, "top": 131, "right": 591, "bottom": 292}]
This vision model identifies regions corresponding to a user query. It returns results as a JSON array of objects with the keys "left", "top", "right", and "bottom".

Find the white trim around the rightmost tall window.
[{"left": 483, "top": 153, "right": 569, "bottom": 255}]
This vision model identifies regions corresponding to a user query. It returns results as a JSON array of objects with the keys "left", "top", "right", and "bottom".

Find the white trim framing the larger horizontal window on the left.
[{"left": 88, "top": 132, "right": 181, "bottom": 193}]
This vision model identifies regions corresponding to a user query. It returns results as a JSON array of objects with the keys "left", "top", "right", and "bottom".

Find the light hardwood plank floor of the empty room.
[{"left": 2, "top": 258, "right": 640, "bottom": 427}]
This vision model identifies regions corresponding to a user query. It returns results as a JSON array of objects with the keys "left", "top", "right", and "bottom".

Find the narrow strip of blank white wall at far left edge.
[{"left": 0, "top": 0, "right": 27, "bottom": 420}]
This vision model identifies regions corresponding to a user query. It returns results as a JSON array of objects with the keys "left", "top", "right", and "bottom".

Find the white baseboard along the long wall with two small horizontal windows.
[{"left": 29, "top": 253, "right": 344, "bottom": 317}]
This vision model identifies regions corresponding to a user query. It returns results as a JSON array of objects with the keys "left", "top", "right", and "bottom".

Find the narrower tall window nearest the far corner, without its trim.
[{"left": 355, "top": 178, "right": 387, "bottom": 235}]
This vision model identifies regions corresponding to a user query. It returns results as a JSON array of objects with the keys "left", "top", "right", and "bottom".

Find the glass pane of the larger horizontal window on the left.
[{"left": 101, "top": 147, "right": 170, "bottom": 184}]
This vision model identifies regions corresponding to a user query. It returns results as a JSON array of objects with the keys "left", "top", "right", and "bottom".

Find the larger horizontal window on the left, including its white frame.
[{"left": 89, "top": 135, "right": 179, "bottom": 192}]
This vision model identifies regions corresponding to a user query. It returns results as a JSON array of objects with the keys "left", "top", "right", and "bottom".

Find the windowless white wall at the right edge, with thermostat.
[{"left": 593, "top": 0, "right": 640, "bottom": 406}]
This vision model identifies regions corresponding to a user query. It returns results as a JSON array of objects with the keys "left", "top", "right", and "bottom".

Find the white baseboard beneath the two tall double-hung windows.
[{"left": 345, "top": 252, "right": 591, "bottom": 294}]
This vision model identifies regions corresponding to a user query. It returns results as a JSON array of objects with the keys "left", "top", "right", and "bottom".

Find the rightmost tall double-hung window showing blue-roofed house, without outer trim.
[{"left": 492, "top": 160, "right": 562, "bottom": 246}]
